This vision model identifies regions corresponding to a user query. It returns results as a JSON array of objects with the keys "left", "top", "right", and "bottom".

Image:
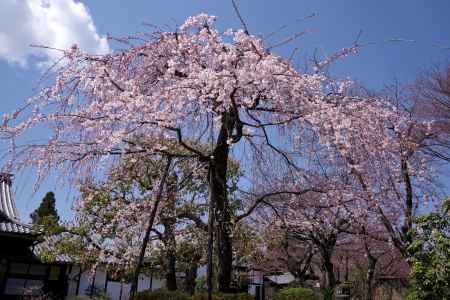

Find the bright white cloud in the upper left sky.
[{"left": 0, "top": 0, "right": 109, "bottom": 67}]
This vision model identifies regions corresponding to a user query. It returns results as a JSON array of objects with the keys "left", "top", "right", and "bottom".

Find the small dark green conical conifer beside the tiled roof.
[{"left": 30, "top": 192, "right": 59, "bottom": 230}]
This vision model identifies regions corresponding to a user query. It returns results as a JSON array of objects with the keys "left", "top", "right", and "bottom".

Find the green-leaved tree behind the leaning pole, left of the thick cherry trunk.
[{"left": 78, "top": 154, "right": 206, "bottom": 290}]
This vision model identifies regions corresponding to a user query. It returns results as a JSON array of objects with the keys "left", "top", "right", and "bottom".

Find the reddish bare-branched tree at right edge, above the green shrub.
[{"left": 362, "top": 69, "right": 450, "bottom": 259}]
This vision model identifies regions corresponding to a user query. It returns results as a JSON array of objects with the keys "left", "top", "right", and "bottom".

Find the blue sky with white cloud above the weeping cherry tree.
[{"left": 0, "top": 0, "right": 450, "bottom": 221}]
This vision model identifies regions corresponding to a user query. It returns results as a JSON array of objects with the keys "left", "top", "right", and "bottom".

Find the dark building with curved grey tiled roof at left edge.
[{"left": 0, "top": 173, "right": 68, "bottom": 300}]
